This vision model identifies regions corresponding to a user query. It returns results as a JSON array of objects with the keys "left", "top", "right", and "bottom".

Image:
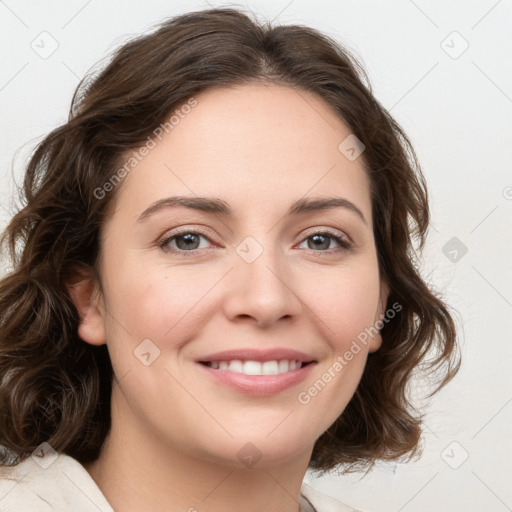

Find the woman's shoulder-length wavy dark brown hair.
[{"left": 0, "top": 8, "right": 460, "bottom": 472}]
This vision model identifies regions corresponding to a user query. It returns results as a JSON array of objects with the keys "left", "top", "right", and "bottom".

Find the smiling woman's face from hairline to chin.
[{"left": 84, "top": 85, "right": 387, "bottom": 467}]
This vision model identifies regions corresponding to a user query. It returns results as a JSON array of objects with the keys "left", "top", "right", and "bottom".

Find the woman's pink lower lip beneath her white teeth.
[{"left": 196, "top": 363, "right": 316, "bottom": 396}]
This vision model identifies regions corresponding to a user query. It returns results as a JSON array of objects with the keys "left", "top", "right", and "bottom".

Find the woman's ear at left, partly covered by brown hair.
[{"left": 66, "top": 271, "right": 106, "bottom": 345}]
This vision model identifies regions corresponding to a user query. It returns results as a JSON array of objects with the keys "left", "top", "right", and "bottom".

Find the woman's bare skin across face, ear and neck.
[{"left": 71, "top": 84, "right": 388, "bottom": 512}]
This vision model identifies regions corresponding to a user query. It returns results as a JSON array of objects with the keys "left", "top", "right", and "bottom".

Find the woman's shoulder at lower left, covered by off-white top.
[{"left": 0, "top": 450, "right": 114, "bottom": 512}]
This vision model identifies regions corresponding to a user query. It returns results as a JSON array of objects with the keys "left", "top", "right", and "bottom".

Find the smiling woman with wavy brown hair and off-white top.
[{"left": 0, "top": 5, "right": 459, "bottom": 512}]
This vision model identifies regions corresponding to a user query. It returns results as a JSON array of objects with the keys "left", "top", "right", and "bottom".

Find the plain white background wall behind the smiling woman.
[{"left": 0, "top": 0, "right": 512, "bottom": 512}]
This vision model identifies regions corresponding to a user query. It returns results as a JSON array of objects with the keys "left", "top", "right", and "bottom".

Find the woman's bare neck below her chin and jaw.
[{"left": 84, "top": 386, "right": 313, "bottom": 512}]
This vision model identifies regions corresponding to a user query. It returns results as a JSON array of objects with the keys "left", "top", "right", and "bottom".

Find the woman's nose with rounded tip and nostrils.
[{"left": 224, "top": 241, "right": 303, "bottom": 327}]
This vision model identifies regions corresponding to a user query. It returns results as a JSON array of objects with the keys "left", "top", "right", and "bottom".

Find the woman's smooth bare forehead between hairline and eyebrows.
[{"left": 110, "top": 84, "right": 371, "bottom": 222}]
